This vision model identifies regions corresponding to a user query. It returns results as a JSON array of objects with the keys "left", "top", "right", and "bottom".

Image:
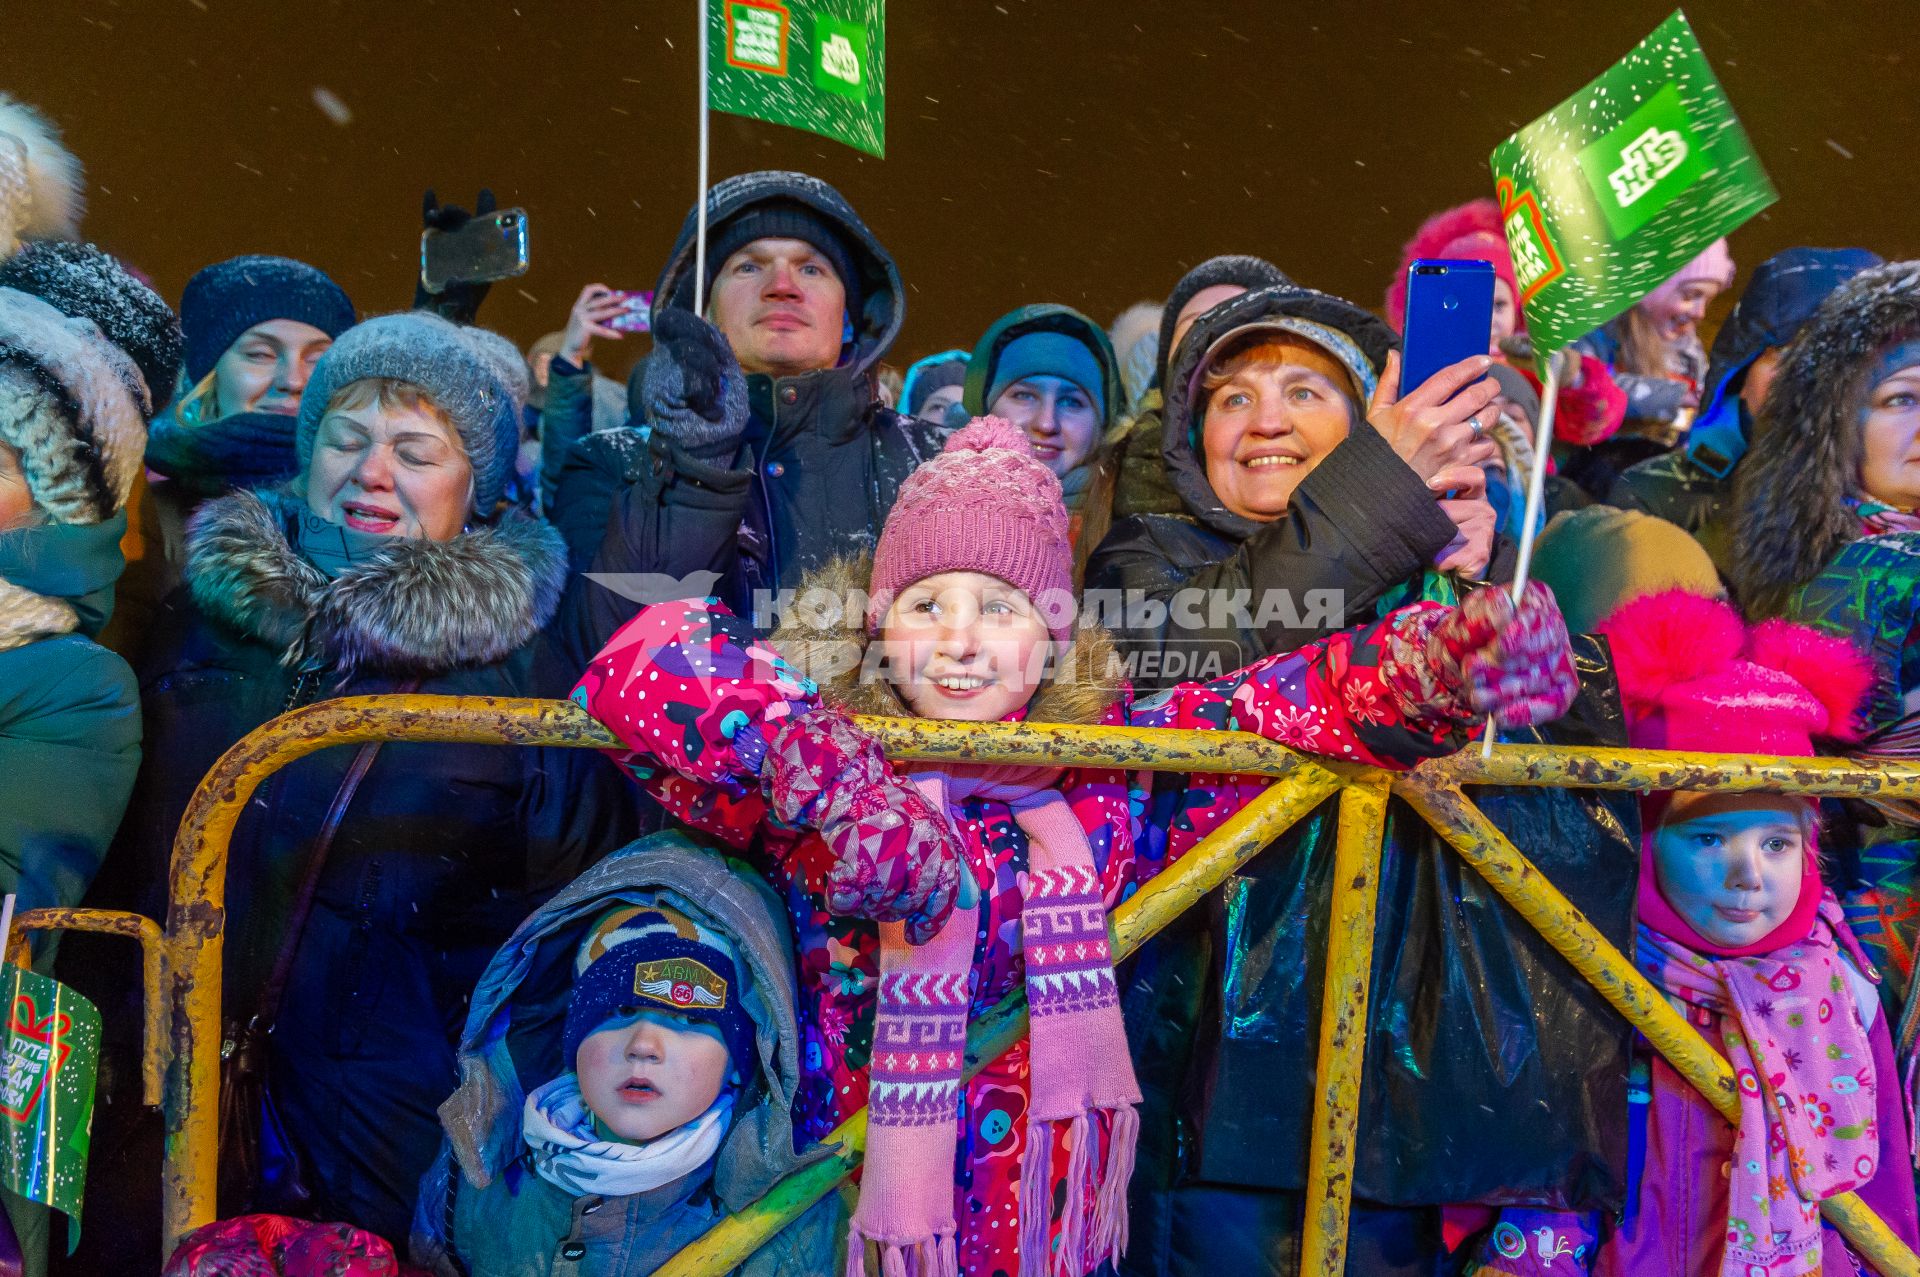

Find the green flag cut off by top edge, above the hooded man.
[{"left": 707, "top": 0, "right": 887, "bottom": 156}]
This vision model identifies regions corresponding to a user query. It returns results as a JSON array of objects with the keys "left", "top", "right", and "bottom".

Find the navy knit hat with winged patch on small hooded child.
[{"left": 561, "top": 904, "right": 755, "bottom": 1077}]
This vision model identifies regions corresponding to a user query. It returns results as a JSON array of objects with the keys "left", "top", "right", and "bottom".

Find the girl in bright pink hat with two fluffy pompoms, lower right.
[{"left": 1478, "top": 591, "right": 1920, "bottom": 1277}]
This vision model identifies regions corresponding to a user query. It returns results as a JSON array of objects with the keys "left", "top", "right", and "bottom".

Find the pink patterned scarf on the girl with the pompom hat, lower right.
[{"left": 1638, "top": 893, "right": 1880, "bottom": 1277}]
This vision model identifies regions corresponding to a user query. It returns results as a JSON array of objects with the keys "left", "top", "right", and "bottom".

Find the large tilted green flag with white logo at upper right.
[{"left": 1492, "top": 12, "right": 1778, "bottom": 359}]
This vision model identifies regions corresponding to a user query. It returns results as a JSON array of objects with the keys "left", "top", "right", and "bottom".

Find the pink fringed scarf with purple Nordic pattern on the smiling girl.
[{"left": 847, "top": 768, "right": 1140, "bottom": 1277}]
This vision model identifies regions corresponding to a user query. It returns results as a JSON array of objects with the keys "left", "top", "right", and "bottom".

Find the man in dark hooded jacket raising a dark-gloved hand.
[{"left": 549, "top": 171, "right": 939, "bottom": 655}]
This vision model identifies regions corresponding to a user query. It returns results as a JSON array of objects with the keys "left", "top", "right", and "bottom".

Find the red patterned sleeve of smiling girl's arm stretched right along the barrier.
[{"left": 1129, "top": 603, "right": 1471, "bottom": 768}]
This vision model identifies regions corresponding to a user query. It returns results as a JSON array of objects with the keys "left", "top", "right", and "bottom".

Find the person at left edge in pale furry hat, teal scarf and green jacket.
[{"left": 0, "top": 288, "right": 148, "bottom": 1273}]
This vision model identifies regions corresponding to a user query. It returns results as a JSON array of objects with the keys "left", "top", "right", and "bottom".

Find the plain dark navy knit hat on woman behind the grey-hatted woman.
[{"left": 180, "top": 255, "right": 353, "bottom": 384}]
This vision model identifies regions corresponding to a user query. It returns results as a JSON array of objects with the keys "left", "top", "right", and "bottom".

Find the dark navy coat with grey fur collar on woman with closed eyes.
[{"left": 96, "top": 492, "right": 634, "bottom": 1242}]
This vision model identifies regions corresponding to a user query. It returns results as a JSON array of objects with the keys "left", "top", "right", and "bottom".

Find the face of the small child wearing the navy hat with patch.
[{"left": 574, "top": 1008, "right": 730, "bottom": 1144}]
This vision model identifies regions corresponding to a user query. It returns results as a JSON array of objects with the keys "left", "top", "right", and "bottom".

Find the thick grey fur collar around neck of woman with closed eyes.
[{"left": 186, "top": 492, "right": 566, "bottom": 676}]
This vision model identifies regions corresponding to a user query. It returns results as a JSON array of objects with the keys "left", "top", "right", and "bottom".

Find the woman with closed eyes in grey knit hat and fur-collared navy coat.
[{"left": 93, "top": 313, "right": 632, "bottom": 1242}]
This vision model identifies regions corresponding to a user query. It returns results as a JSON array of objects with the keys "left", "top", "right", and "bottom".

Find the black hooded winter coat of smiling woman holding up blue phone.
[{"left": 1089, "top": 292, "right": 1638, "bottom": 1277}]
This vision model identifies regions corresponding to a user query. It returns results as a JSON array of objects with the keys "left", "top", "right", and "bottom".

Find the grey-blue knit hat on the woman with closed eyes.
[{"left": 294, "top": 311, "right": 520, "bottom": 518}]
